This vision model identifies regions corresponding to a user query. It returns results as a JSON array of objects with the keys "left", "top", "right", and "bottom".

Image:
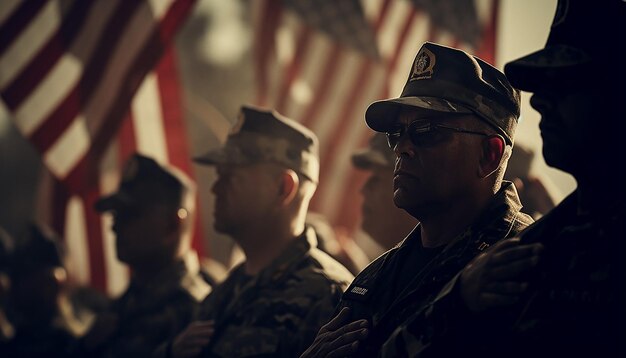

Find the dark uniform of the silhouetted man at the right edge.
[{"left": 382, "top": 192, "right": 626, "bottom": 357}]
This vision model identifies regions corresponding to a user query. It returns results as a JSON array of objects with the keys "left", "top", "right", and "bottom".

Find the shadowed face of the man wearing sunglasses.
[{"left": 393, "top": 109, "right": 484, "bottom": 220}]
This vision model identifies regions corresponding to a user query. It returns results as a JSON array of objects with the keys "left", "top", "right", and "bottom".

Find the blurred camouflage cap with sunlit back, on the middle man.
[{"left": 194, "top": 106, "right": 319, "bottom": 183}]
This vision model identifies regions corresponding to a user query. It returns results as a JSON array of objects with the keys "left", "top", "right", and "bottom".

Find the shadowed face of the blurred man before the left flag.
[{"left": 113, "top": 205, "right": 176, "bottom": 265}]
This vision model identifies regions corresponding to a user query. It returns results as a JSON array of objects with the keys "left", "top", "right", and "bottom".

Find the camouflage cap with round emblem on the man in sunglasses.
[{"left": 365, "top": 42, "right": 520, "bottom": 144}]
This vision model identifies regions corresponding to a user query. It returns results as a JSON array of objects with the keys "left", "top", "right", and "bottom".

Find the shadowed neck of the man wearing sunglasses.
[{"left": 420, "top": 186, "right": 494, "bottom": 247}]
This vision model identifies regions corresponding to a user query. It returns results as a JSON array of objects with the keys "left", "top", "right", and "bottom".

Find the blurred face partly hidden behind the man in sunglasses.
[{"left": 361, "top": 166, "right": 416, "bottom": 249}]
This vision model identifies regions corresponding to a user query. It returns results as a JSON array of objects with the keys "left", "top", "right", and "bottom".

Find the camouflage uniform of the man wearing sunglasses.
[{"left": 337, "top": 182, "right": 532, "bottom": 356}]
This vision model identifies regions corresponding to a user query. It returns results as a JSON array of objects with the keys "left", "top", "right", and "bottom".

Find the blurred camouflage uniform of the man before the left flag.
[{"left": 97, "top": 253, "right": 211, "bottom": 357}]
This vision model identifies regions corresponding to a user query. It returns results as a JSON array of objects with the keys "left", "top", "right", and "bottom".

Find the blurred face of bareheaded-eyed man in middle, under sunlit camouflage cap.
[{"left": 212, "top": 163, "right": 278, "bottom": 235}]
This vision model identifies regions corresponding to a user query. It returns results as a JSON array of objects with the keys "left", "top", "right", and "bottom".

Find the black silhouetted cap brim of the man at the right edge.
[{"left": 504, "top": 45, "right": 591, "bottom": 91}]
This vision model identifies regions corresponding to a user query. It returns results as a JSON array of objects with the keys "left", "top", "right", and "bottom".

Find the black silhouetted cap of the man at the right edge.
[{"left": 504, "top": 0, "right": 626, "bottom": 91}]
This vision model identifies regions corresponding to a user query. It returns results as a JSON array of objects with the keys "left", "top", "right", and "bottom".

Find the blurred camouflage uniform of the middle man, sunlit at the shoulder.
[{"left": 200, "top": 228, "right": 353, "bottom": 357}]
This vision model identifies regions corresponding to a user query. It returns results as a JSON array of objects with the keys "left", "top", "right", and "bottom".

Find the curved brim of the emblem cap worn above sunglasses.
[{"left": 365, "top": 96, "right": 473, "bottom": 132}]
